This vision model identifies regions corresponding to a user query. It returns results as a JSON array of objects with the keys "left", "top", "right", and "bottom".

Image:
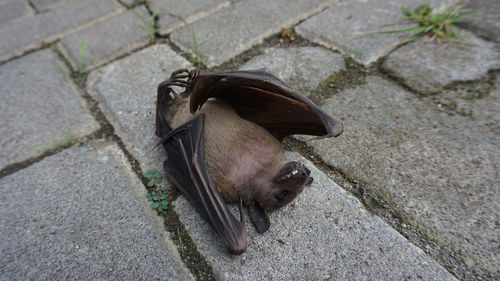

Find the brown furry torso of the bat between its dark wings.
[{"left": 166, "top": 95, "right": 288, "bottom": 209}]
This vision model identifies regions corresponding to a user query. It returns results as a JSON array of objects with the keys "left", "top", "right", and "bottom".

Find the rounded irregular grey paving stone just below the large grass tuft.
[{"left": 383, "top": 31, "right": 500, "bottom": 95}]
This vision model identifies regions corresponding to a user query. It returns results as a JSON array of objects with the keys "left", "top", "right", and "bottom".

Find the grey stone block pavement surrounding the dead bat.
[{"left": 0, "top": 0, "right": 500, "bottom": 280}]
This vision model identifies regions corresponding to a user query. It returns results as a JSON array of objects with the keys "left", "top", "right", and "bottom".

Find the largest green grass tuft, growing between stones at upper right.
[{"left": 371, "top": 3, "right": 476, "bottom": 44}]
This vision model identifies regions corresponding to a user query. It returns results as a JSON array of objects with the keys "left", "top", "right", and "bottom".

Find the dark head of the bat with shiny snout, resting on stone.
[{"left": 256, "top": 161, "right": 313, "bottom": 210}]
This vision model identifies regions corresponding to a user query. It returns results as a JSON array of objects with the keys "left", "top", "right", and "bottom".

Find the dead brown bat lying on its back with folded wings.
[{"left": 155, "top": 69, "right": 343, "bottom": 255}]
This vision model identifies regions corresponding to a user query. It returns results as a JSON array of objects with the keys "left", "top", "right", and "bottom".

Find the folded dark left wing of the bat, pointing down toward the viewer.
[{"left": 160, "top": 111, "right": 247, "bottom": 255}]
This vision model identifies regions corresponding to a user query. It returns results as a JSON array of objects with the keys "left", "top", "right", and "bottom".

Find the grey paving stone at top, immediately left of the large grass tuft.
[{"left": 295, "top": 0, "right": 446, "bottom": 65}]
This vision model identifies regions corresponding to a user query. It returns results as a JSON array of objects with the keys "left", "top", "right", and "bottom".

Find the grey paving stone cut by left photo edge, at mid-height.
[{"left": 0, "top": 50, "right": 99, "bottom": 169}]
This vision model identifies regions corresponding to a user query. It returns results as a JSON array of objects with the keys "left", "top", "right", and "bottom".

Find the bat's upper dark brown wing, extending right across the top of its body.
[{"left": 186, "top": 69, "right": 343, "bottom": 141}]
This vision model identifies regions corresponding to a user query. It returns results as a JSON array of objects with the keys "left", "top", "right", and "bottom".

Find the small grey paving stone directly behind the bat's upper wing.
[{"left": 241, "top": 47, "right": 345, "bottom": 95}]
